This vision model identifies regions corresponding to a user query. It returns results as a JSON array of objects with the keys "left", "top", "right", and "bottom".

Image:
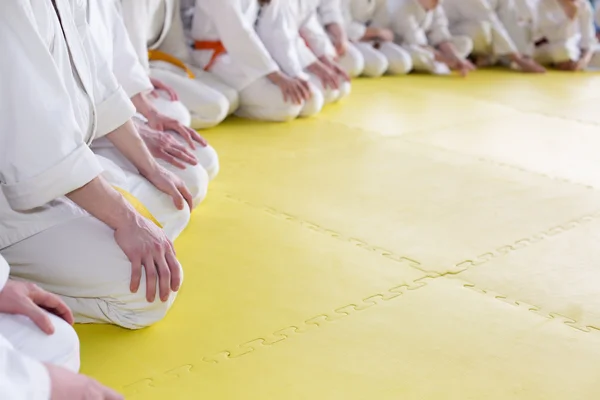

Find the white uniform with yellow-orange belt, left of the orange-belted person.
[{"left": 122, "top": 0, "right": 238, "bottom": 129}]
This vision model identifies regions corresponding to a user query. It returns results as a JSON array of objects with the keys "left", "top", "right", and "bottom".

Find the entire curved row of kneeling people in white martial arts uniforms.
[{"left": 0, "top": 0, "right": 599, "bottom": 400}]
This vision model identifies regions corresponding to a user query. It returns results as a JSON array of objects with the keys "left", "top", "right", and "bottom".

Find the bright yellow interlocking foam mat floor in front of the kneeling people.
[{"left": 77, "top": 71, "right": 600, "bottom": 400}]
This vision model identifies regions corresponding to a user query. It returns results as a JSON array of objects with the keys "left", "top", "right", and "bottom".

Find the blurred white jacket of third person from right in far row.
[{"left": 388, "top": 0, "right": 452, "bottom": 46}]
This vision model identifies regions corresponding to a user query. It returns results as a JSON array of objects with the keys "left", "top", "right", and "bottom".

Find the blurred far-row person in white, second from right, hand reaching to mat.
[{"left": 442, "top": 0, "right": 546, "bottom": 73}]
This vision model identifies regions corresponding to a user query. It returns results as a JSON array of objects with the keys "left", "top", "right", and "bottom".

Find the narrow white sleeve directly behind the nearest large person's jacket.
[{"left": 109, "top": 0, "right": 152, "bottom": 98}]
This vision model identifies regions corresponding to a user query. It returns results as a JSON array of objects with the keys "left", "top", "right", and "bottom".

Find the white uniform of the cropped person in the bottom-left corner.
[{"left": 0, "top": 256, "right": 79, "bottom": 400}]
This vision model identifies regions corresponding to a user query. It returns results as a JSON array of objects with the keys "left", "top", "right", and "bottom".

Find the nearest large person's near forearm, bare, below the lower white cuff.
[{"left": 67, "top": 176, "right": 137, "bottom": 229}]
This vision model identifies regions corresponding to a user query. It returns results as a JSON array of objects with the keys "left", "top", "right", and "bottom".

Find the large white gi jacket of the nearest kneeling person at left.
[{"left": 0, "top": 0, "right": 135, "bottom": 249}]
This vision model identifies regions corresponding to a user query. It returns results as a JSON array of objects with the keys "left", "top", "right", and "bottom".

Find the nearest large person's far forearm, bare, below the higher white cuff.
[{"left": 106, "top": 120, "right": 158, "bottom": 177}]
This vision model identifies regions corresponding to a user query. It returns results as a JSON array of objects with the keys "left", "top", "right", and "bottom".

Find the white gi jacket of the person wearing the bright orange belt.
[{"left": 190, "top": 0, "right": 279, "bottom": 91}]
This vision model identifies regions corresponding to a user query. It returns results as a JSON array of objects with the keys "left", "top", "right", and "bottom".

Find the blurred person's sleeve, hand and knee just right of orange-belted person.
[{"left": 317, "top": 0, "right": 365, "bottom": 78}]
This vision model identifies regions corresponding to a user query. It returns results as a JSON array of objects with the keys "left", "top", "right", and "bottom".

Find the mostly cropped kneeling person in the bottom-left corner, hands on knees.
[{"left": 0, "top": 256, "right": 123, "bottom": 400}]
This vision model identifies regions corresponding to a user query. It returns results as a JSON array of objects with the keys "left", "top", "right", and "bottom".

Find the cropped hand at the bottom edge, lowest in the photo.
[{"left": 45, "top": 364, "right": 125, "bottom": 400}]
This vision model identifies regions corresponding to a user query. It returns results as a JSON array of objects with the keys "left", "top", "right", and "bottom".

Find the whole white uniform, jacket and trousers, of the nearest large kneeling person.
[{"left": 0, "top": 0, "right": 189, "bottom": 328}]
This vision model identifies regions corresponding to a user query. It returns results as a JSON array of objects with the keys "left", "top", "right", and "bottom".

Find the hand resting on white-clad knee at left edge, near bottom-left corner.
[{"left": 0, "top": 279, "right": 74, "bottom": 335}]
